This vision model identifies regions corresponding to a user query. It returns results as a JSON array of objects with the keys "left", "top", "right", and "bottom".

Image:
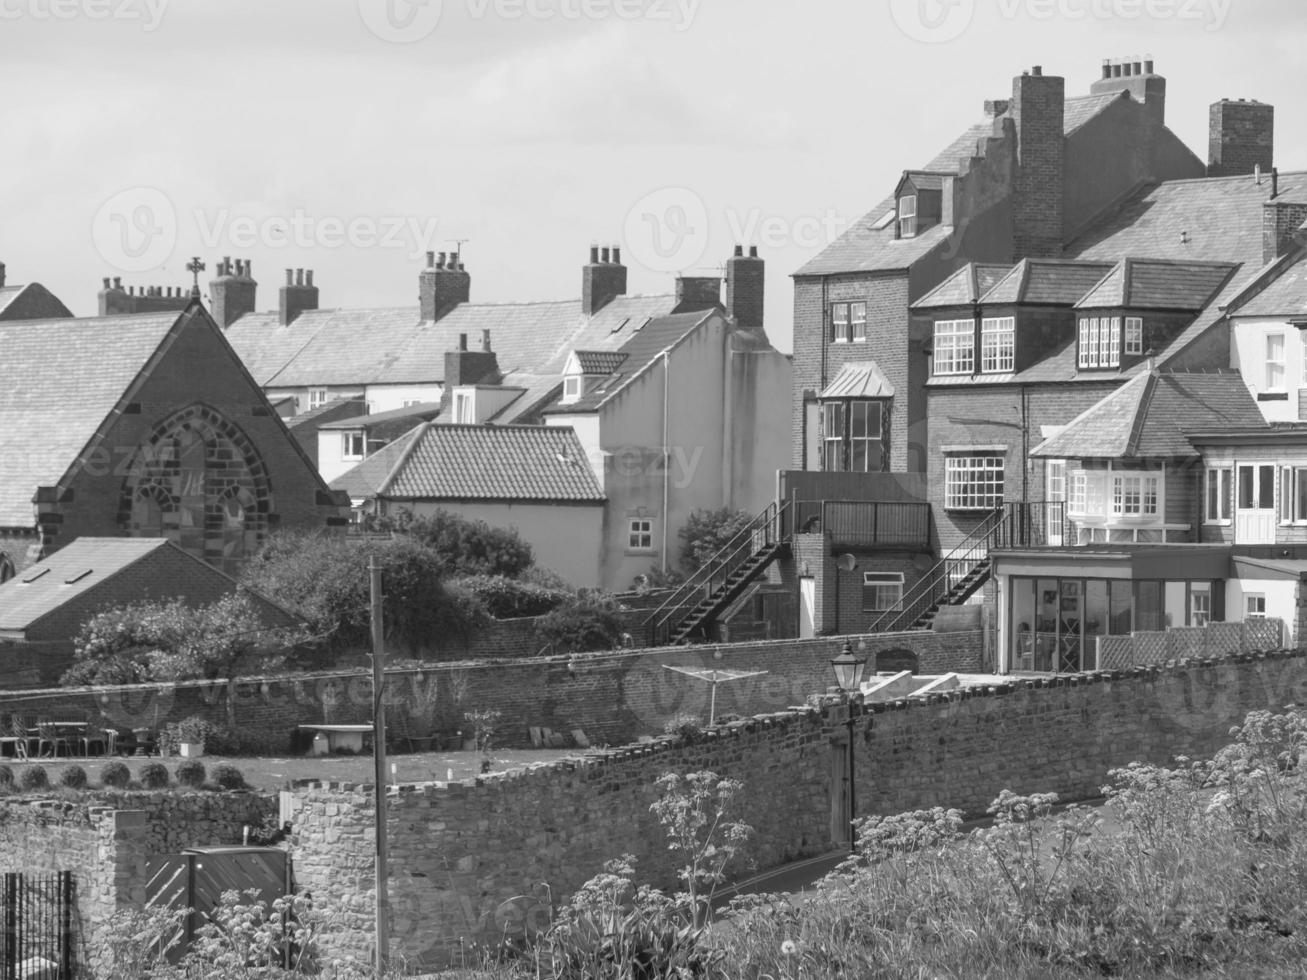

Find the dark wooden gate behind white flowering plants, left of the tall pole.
[{"left": 145, "top": 847, "right": 291, "bottom": 963}]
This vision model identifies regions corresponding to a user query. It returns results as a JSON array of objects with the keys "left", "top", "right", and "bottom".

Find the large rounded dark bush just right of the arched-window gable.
[{"left": 243, "top": 532, "right": 485, "bottom": 652}]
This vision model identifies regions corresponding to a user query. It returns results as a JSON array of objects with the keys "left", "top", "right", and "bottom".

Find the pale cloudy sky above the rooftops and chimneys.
[{"left": 0, "top": 0, "right": 1307, "bottom": 351}]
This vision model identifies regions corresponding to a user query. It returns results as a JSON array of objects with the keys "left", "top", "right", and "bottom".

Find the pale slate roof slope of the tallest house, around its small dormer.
[{"left": 793, "top": 93, "right": 1125, "bottom": 276}]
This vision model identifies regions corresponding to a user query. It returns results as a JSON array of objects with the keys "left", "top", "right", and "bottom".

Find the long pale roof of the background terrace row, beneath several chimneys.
[{"left": 227, "top": 295, "right": 676, "bottom": 391}]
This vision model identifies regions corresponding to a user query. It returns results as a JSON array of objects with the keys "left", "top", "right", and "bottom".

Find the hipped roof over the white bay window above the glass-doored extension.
[{"left": 1030, "top": 370, "right": 1269, "bottom": 459}]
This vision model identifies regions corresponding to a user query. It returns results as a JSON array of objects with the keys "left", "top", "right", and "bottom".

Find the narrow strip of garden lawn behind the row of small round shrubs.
[{"left": 0, "top": 749, "right": 578, "bottom": 792}]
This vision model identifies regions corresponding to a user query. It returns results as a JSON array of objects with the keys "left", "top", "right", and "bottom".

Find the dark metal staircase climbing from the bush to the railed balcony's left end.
[{"left": 644, "top": 502, "right": 791, "bottom": 647}]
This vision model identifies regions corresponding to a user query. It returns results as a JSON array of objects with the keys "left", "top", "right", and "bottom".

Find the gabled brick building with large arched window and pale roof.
[{"left": 0, "top": 303, "right": 348, "bottom": 574}]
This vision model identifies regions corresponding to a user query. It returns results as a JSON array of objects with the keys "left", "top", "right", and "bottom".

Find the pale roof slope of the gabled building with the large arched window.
[{"left": 0, "top": 312, "right": 180, "bottom": 528}]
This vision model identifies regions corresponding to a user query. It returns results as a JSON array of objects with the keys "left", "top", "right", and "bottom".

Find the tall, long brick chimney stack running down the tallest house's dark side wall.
[{"left": 1012, "top": 65, "right": 1067, "bottom": 260}]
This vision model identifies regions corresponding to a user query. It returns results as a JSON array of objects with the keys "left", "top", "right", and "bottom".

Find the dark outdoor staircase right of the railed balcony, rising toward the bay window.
[{"left": 870, "top": 503, "right": 1064, "bottom": 632}]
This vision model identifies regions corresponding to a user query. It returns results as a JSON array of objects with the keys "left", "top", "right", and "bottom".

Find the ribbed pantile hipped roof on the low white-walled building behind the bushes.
[{"left": 332, "top": 422, "right": 604, "bottom": 503}]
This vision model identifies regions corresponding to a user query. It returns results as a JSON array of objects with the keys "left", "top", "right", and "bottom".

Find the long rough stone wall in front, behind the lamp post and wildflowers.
[{"left": 290, "top": 652, "right": 1307, "bottom": 964}]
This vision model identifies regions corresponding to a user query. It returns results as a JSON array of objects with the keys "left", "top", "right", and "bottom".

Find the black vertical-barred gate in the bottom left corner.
[{"left": 0, "top": 872, "right": 78, "bottom": 980}]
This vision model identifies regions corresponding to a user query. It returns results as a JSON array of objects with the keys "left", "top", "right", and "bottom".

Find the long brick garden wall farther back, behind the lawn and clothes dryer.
[{"left": 0, "top": 632, "right": 982, "bottom": 753}]
